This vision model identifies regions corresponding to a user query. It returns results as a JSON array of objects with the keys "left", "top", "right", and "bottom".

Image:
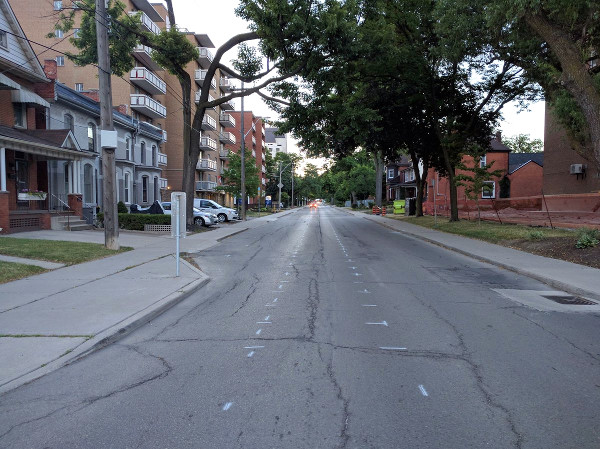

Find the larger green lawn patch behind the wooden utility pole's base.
[{"left": 0, "top": 237, "right": 132, "bottom": 265}]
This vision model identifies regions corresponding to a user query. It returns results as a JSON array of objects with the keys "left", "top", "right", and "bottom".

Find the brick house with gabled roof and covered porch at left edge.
[{"left": 0, "top": 0, "right": 85, "bottom": 233}]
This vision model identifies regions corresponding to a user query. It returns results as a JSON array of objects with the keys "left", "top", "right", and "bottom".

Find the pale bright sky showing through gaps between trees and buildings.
[{"left": 163, "top": 0, "right": 544, "bottom": 166}]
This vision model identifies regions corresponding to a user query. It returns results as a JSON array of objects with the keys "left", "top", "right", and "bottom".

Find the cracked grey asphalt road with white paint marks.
[{"left": 0, "top": 207, "right": 600, "bottom": 449}]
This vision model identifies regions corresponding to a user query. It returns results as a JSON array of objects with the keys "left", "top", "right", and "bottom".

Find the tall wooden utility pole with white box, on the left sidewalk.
[{"left": 96, "top": 0, "right": 119, "bottom": 250}]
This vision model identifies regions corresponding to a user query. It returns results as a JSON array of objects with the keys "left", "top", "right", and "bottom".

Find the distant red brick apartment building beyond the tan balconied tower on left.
[{"left": 226, "top": 111, "right": 268, "bottom": 204}]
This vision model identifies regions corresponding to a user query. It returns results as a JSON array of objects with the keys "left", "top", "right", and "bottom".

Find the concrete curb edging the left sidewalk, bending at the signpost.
[{"left": 0, "top": 259, "right": 210, "bottom": 394}]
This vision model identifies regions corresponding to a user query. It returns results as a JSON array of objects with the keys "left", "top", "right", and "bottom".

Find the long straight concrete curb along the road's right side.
[{"left": 348, "top": 212, "right": 600, "bottom": 301}]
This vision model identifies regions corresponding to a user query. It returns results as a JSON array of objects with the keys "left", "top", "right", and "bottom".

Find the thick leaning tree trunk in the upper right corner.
[{"left": 524, "top": 13, "right": 600, "bottom": 167}]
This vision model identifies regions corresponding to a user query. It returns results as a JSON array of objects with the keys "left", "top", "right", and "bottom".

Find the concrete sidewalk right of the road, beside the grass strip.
[{"left": 344, "top": 209, "right": 600, "bottom": 301}]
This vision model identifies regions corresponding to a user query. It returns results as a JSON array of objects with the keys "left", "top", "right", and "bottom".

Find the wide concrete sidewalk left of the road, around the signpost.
[{"left": 0, "top": 211, "right": 300, "bottom": 393}]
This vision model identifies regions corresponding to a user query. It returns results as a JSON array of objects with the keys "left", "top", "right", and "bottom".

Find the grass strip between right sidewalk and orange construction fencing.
[{"left": 388, "top": 214, "right": 576, "bottom": 243}]
